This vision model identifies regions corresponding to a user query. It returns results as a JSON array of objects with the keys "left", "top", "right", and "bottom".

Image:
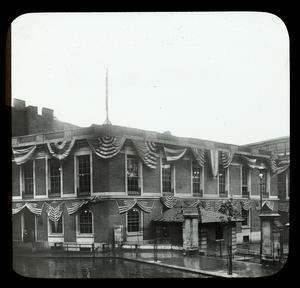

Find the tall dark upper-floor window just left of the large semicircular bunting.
[{"left": 77, "top": 155, "right": 91, "bottom": 194}]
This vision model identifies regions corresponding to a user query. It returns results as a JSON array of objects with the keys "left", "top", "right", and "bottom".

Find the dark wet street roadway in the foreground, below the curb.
[{"left": 13, "top": 257, "right": 208, "bottom": 278}]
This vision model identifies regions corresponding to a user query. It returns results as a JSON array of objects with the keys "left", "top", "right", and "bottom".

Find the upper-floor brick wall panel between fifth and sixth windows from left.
[{"left": 175, "top": 159, "right": 191, "bottom": 194}]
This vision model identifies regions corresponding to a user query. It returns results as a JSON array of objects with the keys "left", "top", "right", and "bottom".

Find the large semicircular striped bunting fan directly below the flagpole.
[{"left": 88, "top": 136, "right": 126, "bottom": 159}]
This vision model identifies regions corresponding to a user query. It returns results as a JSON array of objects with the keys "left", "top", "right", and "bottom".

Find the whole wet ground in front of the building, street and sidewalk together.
[{"left": 14, "top": 249, "right": 280, "bottom": 278}]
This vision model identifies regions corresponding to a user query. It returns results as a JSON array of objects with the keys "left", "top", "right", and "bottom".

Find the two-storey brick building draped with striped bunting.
[{"left": 12, "top": 100, "right": 288, "bottom": 254}]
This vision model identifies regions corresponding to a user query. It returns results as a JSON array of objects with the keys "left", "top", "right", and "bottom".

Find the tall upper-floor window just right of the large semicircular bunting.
[{"left": 127, "top": 155, "right": 140, "bottom": 195}]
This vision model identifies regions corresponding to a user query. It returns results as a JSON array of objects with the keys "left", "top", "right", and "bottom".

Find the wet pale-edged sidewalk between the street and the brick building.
[{"left": 14, "top": 249, "right": 286, "bottom": 278}]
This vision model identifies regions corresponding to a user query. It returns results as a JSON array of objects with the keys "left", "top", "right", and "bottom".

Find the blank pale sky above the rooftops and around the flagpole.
[{"left": 12, "top": 12, "right": 290, "bottom": 145}]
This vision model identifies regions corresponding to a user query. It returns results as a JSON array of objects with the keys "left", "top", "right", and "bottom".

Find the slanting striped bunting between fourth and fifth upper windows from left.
[{"left": 131, "top": 139, "right": 159, "bottom": 169}]
